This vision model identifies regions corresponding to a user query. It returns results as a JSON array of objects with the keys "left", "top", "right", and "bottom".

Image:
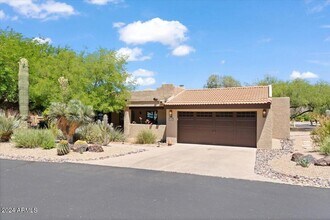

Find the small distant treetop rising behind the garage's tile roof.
[{"left": 204, "top": 74, "right": 241, "bottom": 88}]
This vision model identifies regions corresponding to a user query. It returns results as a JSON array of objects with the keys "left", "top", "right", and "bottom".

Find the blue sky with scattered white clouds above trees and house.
[{"left": 0, "top": 0, "right": 330, "bottom": 89}]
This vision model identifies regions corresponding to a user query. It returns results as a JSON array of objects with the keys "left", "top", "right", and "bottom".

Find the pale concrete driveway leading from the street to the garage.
[{"left": 76, "top": 144, "right": 274, "bottom": 182}]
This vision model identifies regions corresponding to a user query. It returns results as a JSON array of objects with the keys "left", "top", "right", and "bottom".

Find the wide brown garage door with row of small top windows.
[{"left": 178, "top": 112, "right": 257, "bottom": 147}]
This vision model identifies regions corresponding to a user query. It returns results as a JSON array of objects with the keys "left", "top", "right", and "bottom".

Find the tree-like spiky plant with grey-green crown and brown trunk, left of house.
[{"left": 48, "top": 100, "right": 94, "bottom": 143}]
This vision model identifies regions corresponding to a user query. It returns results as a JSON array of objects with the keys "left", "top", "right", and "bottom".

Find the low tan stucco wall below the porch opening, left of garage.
[{"left": 128, "top": 124, "right": 166, "bottom": 141}]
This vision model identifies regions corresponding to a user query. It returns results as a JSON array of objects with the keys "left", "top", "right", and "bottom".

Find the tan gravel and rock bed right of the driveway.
[{"left": 255, "top": 132, "right": 330, "bottom": 188}]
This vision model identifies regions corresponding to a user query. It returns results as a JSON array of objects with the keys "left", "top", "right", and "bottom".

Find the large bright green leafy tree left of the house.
[{"left": 0, "top": 29, "right": 132, "bottom": 112}]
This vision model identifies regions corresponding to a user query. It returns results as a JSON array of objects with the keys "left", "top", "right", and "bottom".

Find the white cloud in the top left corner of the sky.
[{"left": 0, "top": 0, "right": 76, "bottom": 20}]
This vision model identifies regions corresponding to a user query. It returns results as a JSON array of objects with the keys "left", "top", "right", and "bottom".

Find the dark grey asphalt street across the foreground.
[{"left": 0, "top": 160, "right": 330, "bottom": 220}]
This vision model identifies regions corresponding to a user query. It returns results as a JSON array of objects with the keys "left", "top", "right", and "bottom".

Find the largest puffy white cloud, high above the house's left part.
[{"left": 119, "top": 18, "right": 188, "bottom": 47}]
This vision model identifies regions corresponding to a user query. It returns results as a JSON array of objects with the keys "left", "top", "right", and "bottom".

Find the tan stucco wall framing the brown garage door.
[{"left": 166, "top": 109, "right": 272, "bottom": 149}]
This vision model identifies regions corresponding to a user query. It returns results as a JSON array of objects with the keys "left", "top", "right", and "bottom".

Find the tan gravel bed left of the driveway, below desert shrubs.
[{"left": 0, "top": 143, "right": 146, "bottom": 162}]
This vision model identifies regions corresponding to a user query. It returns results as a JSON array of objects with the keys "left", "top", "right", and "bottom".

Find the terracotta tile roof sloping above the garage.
[{"left": 165, "top": 86, "right": 271, "bottom": 105}]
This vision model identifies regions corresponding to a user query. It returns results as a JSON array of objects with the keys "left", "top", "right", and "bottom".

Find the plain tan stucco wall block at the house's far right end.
[{"left": 271, "top": 97, "right": 290, "bottom": 139}]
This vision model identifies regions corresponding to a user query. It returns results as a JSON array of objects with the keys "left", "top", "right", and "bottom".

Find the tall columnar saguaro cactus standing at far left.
[{"left": 18, "top": 58, "right": 29, "bottom": 122}]
